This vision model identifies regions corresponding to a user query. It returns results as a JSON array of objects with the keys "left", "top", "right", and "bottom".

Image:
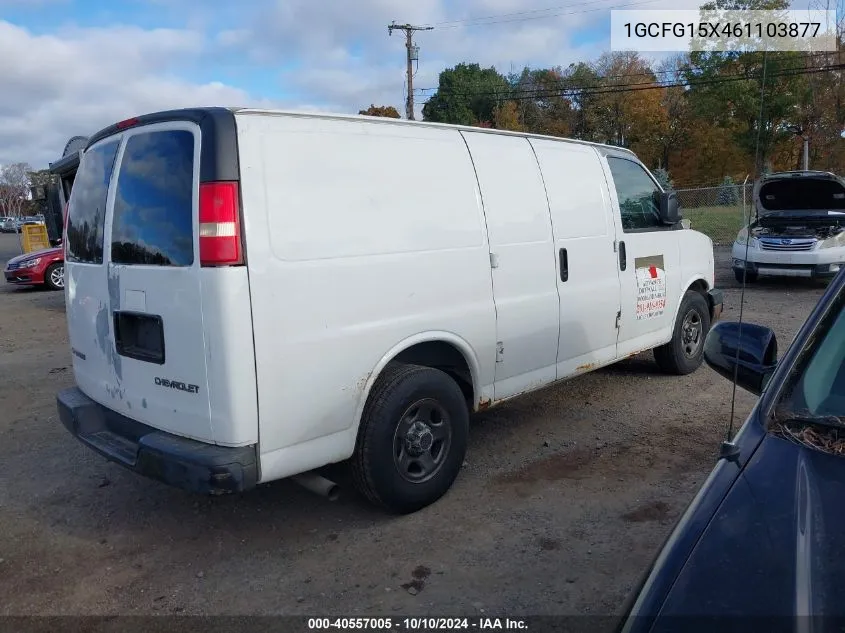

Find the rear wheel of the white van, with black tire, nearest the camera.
[{"left": 351, "top": 363, "right": 469, "bottom": 514}]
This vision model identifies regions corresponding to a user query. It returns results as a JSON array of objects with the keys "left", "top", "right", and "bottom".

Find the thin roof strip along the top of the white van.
[{"left": 86, "top": 107, "right": 636, "bottom": 158}]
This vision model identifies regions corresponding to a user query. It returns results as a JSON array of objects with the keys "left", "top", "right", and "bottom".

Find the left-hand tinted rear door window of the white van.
[{"left": 67, "top": 141, "right": 119, "bottom": 264}]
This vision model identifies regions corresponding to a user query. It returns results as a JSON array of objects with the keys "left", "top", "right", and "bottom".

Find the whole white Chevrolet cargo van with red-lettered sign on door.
[{"left": 57, "top": 108, "right": 722, "bottom": 512}]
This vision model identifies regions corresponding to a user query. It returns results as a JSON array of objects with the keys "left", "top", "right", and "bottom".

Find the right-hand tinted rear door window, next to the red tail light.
[{"left": 111, "top": 130, "right": 194, "bottom": 266}]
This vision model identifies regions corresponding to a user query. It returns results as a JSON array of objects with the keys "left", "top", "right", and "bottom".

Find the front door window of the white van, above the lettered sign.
[{"left": 607, "top": 156, "right": 664, "bottom": 231}]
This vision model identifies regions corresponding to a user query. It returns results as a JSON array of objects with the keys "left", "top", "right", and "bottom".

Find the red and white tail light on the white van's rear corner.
[{"left": 200, "top": 181, "right": 244, "bottom": 266}]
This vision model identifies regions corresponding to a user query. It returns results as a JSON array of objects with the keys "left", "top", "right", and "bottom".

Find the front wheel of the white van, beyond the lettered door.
[{"left": 654, "top": 290, "right": 710, "bottom": 376}]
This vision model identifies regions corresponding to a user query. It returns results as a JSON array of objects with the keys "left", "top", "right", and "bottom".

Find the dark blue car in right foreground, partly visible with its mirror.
[{"left": 619, "top": 273, "right": 845, "bottom": 633}]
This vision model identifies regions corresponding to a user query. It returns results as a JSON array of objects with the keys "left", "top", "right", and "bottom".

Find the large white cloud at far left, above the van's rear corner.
[{"left": 0, "top": 21, "right": 271, "bottom": 168}]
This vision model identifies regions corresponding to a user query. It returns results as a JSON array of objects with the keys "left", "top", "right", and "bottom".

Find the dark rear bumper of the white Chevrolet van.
[{"left": 56, "top": 387, "right": 258, "bottom": 495}]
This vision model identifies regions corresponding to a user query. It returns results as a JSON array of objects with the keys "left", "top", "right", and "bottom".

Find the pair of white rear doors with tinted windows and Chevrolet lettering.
[{"left": 65, "top": 120, "right": 221, "bottom": 442}]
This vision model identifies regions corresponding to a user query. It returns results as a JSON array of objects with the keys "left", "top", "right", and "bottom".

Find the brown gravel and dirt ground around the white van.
[{"left": 0, "top": 235, "right": 823, "bottom": 616}]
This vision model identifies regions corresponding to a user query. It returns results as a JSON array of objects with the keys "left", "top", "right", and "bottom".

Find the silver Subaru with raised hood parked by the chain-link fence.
[{"left": 732, "top": 171, "right": 845, "bottom": 282}]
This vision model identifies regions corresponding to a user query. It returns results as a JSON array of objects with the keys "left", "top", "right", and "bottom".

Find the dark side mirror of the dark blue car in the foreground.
[{"left": 704, "top": 321, "right": 778, "bottom": 396}]
